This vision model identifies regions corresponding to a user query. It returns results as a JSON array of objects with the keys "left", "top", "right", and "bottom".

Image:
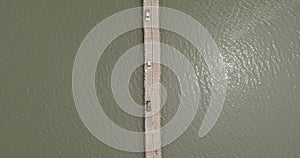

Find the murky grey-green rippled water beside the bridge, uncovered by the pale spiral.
[{"left": 0, "top": 0, "right": 300, "bottom": 158}]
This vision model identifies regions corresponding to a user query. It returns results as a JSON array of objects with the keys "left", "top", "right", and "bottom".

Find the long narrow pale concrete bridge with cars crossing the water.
[{"left": 143, "top": 0, "right": 161, "bottom": 158}]
